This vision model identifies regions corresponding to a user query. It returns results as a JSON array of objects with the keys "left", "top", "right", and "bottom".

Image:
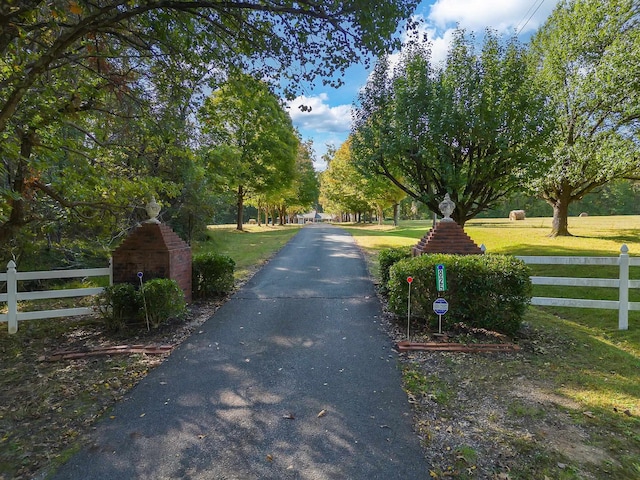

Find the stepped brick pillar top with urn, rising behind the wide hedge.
[{"left": 411, "top": 193, "right": 484, "bottom": 257}]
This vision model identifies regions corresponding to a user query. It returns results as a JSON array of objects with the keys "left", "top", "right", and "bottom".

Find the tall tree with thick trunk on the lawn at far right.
[{"left": 532, "top": 0, "right": 640, "bottom": 236}]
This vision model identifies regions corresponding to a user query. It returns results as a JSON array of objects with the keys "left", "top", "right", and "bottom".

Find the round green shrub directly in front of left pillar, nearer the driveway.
[{"left": 139, "top": 278, "right": 187, "bottom": 328}]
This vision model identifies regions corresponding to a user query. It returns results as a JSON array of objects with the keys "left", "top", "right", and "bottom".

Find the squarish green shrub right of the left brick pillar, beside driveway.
[{"left": 191, "top": 253, "right": 236, "bottom": 298}]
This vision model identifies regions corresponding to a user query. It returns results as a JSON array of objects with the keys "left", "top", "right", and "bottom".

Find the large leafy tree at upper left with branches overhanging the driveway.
[{"left": 0, "top": 0, "right": 415, "bottom": 246}]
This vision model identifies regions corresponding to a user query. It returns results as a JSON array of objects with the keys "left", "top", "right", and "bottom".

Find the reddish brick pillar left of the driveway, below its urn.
[{"left": 113, "top": 222, "right": 191, "bottom": 302}]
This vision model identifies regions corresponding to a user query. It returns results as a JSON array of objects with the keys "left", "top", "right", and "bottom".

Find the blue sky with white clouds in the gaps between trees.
[{"left": 289, "top": 0, "right": 557, "bottom": 170}]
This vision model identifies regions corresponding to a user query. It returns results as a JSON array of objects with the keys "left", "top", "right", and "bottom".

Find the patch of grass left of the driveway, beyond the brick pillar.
[{"left": 192, "top": 225, "right": 300, "bottom": 279}]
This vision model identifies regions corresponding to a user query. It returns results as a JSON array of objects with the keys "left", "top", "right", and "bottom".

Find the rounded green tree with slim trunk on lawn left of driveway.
[{"left": 200, "top": 75, "right": 299, "bottom": 230}]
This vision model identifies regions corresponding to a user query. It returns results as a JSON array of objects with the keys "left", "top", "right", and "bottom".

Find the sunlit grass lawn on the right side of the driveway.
[{"left": 345, "top": 216, "right": 640, "bottom": 479}]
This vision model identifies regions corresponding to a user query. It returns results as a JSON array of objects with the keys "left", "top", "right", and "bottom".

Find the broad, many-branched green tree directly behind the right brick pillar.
[{"left": 352, "top": 30, "right": 551, "bottom": 225}]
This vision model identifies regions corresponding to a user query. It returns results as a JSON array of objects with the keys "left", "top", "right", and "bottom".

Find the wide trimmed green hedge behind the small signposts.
[{"left": 389, "top": 254, "right": 531, "bottom": 335}]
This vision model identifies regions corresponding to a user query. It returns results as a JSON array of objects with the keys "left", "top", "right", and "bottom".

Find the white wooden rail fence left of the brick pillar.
[{"left": 0, "top": 260, "right": 113, "bottom": 333}]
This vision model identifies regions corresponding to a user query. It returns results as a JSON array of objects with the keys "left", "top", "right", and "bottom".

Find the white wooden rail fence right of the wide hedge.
[{"left": 516, "top": 245, "right": 640, "bottom": 330}]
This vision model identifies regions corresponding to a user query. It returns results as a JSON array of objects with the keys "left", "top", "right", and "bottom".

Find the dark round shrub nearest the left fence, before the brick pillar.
[{"left": 98, "top": 283, "right": 144, "bottom": 332}]
